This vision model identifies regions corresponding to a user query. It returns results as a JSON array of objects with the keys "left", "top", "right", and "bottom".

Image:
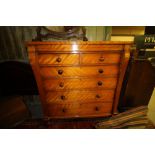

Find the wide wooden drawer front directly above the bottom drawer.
[{"left": 46, "top": 90, "right": 114, "bottom": 104}]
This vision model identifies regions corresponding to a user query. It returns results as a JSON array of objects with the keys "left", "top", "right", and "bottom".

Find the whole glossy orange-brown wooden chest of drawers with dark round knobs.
[{"left": 27, "top": 41, "right": 131, "bottom": 118}]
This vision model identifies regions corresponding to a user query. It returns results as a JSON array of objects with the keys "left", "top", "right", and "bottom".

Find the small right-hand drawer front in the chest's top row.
[{"left": 82, "top": 53, "right": 120, "bottom": 64}]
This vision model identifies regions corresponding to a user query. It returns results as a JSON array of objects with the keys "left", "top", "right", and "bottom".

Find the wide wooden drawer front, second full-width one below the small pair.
[{"left": 43, "top": 78, "right": 117, "bottom": 91}]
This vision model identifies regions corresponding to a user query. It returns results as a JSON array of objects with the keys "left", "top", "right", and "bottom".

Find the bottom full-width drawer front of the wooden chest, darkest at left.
[{"left": 46, "top": 102, "right": 112, "bottom": 118}]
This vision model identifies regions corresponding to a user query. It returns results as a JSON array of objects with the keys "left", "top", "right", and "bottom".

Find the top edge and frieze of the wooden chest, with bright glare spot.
[{"left": 27, "top": 41, "right": 131, "bottom": 53}]
